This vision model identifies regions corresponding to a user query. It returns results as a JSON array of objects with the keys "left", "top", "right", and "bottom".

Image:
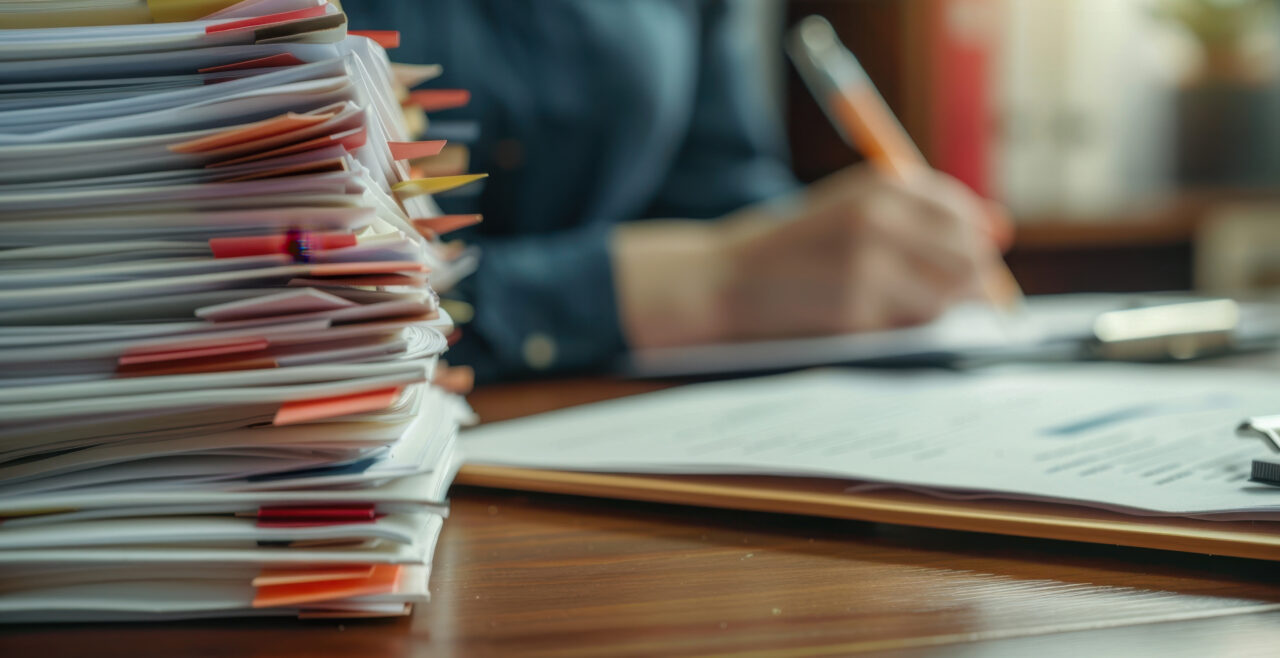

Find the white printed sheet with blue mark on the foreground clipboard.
[{"left": 462, "top": 364, "right": 1280, "bottom": 520}]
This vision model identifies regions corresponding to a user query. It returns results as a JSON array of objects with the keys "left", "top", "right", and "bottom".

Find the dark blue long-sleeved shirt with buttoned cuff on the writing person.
[{"left": 344, "top": 0, "right": 795, "bottom": 380}]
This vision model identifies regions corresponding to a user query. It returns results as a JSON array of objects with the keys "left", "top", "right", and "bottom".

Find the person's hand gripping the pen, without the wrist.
[{"left": 722, "top": 168, "right": 1002, "bottom": 339}]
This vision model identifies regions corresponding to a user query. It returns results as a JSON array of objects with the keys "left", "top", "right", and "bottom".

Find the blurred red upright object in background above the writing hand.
[{"left": 925, "top": 0, "right": 997, "bottom": 197}]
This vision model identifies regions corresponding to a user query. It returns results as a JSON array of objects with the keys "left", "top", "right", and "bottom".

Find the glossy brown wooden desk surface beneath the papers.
[{"left": 0, "top": 380, "right": 1280, "bottom": 658}]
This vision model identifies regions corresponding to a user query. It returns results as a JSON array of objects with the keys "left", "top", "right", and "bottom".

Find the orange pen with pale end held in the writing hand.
[{"left": 787, "top": 15, "right": 1023, "bottom": 306}]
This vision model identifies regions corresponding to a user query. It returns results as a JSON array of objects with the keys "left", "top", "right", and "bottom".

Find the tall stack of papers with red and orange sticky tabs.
[{"left": 0, "top": 0, "right": 474, "bottom": 622}]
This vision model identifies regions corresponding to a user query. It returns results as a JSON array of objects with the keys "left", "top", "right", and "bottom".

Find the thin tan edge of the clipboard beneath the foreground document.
[{"left": 454, "top": 465, "right": 1280, "bottom": 561}]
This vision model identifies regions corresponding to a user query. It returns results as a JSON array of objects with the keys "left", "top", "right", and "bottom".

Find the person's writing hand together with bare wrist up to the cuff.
[{"left": 614, "top": 168, "right": 1004, "bottom": 347}]
